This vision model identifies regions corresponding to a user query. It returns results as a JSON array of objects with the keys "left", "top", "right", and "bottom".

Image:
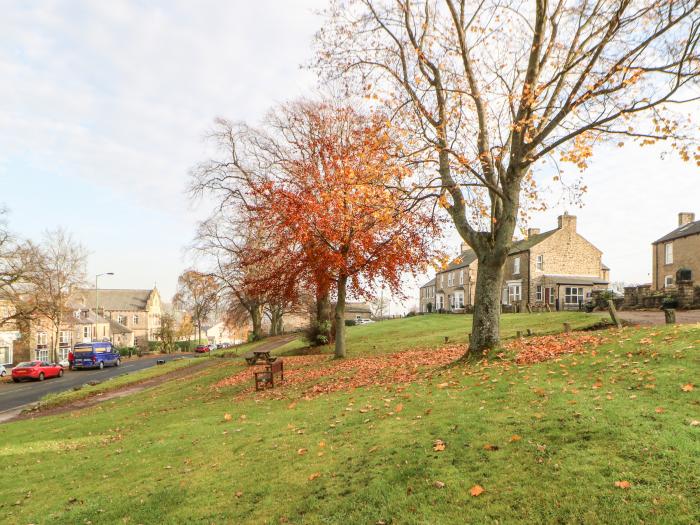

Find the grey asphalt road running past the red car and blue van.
[{"left": 0, "top": 355, "right": 191, "bottom": 416}]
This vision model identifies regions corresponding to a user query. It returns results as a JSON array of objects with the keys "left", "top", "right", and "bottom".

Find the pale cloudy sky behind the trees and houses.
[{"left": 0, "top": 0, "right": 700, "bottom": 306}]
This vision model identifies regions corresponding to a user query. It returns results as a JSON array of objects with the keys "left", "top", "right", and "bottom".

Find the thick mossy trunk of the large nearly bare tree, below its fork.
[{"left": 468, "top": 253, "right": 507, "bottom": 354}]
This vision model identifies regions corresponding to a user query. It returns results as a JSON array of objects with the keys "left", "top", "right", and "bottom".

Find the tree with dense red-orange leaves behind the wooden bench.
[{"left": 252, "top": 101, "right": 439, "bottom": 357}]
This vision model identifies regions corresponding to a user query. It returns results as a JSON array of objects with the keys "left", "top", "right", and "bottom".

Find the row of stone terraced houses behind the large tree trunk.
[{"left": 421, "top": 214, "right": 610, "bottom": 312}]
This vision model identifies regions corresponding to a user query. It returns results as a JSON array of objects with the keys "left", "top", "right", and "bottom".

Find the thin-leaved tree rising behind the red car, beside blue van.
[{"left": 28, "top": 229, "right": 87, "bottom": 361}]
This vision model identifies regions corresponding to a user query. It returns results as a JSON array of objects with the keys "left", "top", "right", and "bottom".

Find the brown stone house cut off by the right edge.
[{"left": 652, "top": 212, "right": 700, "bottom": 291}]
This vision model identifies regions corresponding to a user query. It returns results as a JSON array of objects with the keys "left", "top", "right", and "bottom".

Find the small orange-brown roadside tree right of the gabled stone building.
[{"left": 173, "top": 270, "right": 219, "bottom": 343}]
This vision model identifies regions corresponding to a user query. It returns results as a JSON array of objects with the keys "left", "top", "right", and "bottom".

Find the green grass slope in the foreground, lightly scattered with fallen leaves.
[{"left": 0, "top": 314, "right": 700, "bottom": 523}]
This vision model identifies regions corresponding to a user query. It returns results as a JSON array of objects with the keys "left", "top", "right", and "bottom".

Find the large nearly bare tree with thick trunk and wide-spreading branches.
[{"left": 316, "top": 0, "right": 700, "bottom": 352}]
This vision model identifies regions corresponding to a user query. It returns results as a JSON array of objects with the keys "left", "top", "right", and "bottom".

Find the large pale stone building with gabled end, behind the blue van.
[{"left": 76, "top": 288, "right": 163, "bottom": 347}]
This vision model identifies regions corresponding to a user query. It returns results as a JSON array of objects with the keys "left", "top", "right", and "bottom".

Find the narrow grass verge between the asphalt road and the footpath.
[{"left": 37, "top": 359, "right": 201, "bottom": 410}]
